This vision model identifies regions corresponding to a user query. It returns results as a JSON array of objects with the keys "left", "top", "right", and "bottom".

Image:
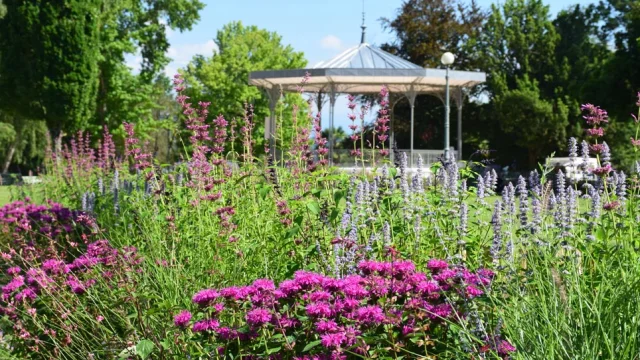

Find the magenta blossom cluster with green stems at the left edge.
[{"left": 0, "top": 202, "right": 142, "bottom": 354}]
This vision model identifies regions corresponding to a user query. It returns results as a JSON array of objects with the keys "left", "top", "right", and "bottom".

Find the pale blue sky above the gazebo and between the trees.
[{"left": 128, "top": 0, "right": 593, "bottom": 131}]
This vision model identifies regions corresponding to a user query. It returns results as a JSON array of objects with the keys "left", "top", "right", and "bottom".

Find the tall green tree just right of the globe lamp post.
[{"left": 480, "top": 0, "right": 570, "bottom": 167}]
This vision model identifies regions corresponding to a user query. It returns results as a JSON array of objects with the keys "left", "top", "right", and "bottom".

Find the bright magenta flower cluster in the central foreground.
[{"left": 174, "top": 260, "right": 515, "bottom": 359}]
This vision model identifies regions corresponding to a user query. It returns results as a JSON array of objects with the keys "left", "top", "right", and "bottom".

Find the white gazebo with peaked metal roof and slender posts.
[{"left": 249, "top": 24, "right": 486, "bottom": 166}]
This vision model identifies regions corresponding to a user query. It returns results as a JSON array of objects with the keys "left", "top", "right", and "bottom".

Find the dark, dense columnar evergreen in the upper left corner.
[{"left": 0, "top": 0, "right": 100, "bottom": 132}]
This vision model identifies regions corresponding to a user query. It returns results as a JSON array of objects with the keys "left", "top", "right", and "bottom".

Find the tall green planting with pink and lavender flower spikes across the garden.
[{"left": 0, "top": 80, "right": 640, "bottom": 359}]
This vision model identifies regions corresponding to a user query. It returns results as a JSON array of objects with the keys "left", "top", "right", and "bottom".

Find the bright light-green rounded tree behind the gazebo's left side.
[{"left": 185, "top": 22, "right": 307, "bottom": 150}]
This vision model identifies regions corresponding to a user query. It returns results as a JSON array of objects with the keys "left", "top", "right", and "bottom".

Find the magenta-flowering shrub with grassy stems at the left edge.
[{"left": 0, "top": 203, "right": 142, "bottom": 359}]
